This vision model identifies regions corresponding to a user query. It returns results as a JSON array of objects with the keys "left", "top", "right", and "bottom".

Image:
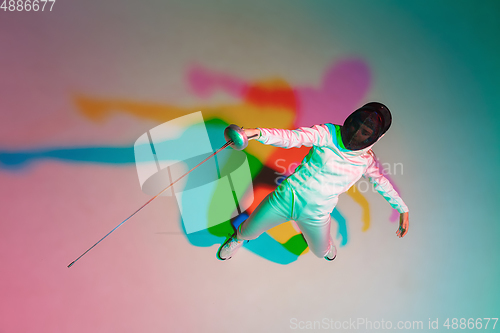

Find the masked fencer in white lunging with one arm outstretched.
[{"left": 217, "top": 102, "right": 409, "bottom": 260}]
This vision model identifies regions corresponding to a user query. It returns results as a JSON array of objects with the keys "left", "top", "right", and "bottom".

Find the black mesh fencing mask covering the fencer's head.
[{"left": 340, "top": 102, "right": 392, "bottom": 150}]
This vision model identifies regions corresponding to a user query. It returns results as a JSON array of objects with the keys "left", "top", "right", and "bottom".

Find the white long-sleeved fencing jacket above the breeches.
[{"left": 257, "top": 124, "right": 408, "bottom": 220}]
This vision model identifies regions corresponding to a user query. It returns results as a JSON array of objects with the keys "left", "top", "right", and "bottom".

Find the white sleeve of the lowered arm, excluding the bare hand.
[{"left": 363, "top": 156, "right": 408, "bottom": 213}]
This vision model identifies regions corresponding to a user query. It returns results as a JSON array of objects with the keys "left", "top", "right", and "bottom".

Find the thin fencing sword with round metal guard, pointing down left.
[{"left": 68, "top": 124, "right": 257, "bottom": 268}]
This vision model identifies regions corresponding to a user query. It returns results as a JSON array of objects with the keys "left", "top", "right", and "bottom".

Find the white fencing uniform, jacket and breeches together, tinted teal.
[{"left": 237, "top": 124, "right": 408, "bottom": 257}]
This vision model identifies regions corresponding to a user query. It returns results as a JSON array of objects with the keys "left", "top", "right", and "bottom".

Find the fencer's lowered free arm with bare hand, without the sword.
[{"left": 363, "top": 157, "right": 410, "bottom": 238}]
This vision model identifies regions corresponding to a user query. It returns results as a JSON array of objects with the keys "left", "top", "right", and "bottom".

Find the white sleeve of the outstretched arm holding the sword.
[{"left": 257, "top": 124, "right": 335, "bottom": 148}]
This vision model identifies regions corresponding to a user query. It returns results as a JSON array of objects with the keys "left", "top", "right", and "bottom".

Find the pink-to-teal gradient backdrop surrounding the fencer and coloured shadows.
[{"left": 0, "top": 0, "right": 500, "bottom": 333}]
